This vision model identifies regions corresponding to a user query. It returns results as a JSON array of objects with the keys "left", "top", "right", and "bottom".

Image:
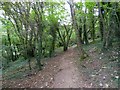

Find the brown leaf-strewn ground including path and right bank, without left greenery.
[{"left": 3, "top": 41, "right": 119, "bottom": 88}]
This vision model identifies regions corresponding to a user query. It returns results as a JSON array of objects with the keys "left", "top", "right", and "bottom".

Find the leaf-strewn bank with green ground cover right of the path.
[{"left": 79, "top": 43, "right": 120, "bottom": 88}]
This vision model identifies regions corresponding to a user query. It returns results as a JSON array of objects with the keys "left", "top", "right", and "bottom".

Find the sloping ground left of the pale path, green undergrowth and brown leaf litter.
[{"left": 2, "top": 46, "right": 63, "bottom": 88}]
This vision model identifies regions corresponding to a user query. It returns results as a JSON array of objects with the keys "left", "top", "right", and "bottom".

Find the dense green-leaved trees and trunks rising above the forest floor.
[{"left": 0, "top": 0, "right": 120, "bottom": 88}]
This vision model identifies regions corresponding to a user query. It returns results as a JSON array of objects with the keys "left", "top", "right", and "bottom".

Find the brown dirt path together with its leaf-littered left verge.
[{"left": 4, "top": 47, "right": 86, "bottom": 88}]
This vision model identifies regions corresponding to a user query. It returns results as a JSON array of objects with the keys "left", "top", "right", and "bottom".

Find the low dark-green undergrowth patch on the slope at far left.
[{"left": 2, "top": 59, "right": 41, "bottom": 80}]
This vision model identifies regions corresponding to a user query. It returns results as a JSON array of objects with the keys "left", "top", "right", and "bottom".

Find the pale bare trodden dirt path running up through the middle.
[{"left": 53, "top": 48, "right": 84, "bottom": 88}]
